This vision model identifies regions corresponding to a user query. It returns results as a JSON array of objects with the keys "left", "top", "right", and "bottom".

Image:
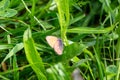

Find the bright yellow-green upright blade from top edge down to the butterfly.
[{"left": 55, "top": 0, "right": 70, "bottom": 45}]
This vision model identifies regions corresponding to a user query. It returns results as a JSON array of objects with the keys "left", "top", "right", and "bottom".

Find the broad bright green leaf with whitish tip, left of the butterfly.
[{"left": 23, "top": 28, "right": 47, "bottom": 80}]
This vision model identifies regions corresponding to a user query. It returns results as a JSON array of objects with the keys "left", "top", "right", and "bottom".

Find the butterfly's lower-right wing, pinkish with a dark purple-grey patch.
[{"left": 54, "top": 39, "right": 63, "bottom": 55}]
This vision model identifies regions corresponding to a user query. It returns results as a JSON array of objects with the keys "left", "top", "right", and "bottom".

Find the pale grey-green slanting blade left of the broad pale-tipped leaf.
[{"left": 2, "top": 43, "right": 23, "bottom": 62}]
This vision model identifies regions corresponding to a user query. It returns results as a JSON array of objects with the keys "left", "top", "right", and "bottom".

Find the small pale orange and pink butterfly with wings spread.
[{"left": 46, "top": 36, "right": 63, "bottom": 55}]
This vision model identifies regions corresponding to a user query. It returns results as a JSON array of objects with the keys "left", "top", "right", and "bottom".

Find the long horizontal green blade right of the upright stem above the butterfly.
[{"left": 67, "top": 26, "right": 115, "bottom": 34}]
